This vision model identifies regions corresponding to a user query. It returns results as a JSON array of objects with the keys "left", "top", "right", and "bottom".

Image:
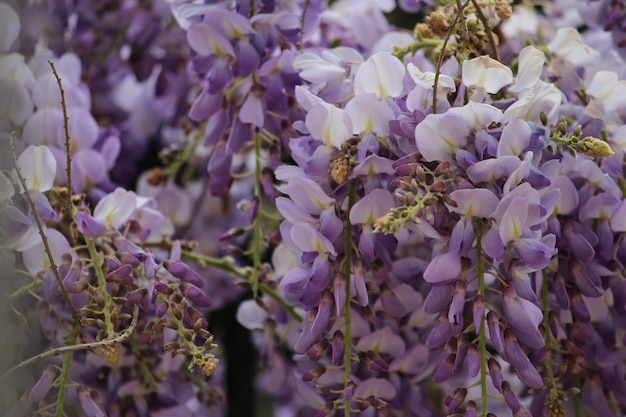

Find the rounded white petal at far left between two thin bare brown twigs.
[{"left": 13, "top": 145, "right": 57, "bottom": 193}]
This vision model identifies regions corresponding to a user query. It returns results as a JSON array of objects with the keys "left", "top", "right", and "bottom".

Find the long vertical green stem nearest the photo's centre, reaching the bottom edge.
[{"left": 343, "top": 180, "right": 356, "bottom": 417}]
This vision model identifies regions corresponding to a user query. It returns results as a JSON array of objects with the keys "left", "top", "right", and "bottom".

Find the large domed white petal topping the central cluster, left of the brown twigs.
[{"left": 354, "top": 52, "right": 406, "bottom": 99}]
